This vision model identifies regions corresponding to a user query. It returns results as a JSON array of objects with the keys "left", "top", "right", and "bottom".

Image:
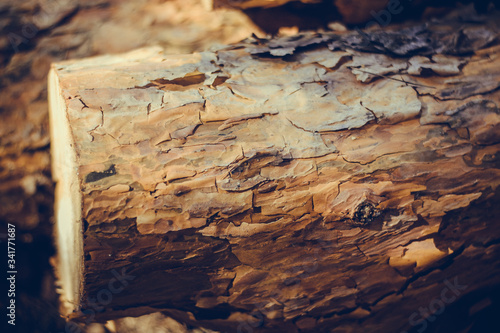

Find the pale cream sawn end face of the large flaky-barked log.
[{"left": 48, "top": 69, "right": 83, "bottom": 314}]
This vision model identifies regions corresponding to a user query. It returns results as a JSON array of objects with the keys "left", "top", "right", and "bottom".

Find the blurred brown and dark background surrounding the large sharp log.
[{"left": 0, "top": 0, "right": 499, "bottom": 333}]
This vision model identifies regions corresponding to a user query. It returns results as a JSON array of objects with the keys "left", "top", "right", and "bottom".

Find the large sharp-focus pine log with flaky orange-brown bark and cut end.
[{"left": 49, "top": 14, "right": 500, "bottom": 332}]
